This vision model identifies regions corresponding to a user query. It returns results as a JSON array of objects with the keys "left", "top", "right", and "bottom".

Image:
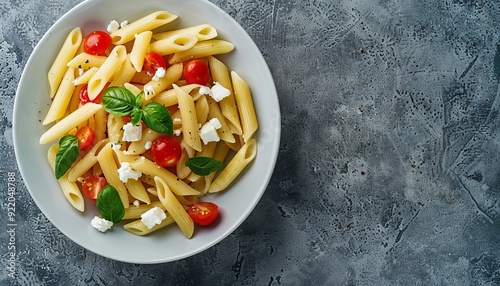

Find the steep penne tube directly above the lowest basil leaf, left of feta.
[{"left": 97, "top": 143, "right": 129, "bottom": 208}]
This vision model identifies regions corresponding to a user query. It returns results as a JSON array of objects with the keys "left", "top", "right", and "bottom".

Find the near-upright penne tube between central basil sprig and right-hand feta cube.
[{"left": 173, "top": 84, "right": 201, "bottom": 151}]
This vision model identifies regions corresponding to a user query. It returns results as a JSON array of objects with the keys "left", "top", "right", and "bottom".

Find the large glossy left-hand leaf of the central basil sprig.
[{"left": 102, "top": 86, "right": 140, "bottom": 116}]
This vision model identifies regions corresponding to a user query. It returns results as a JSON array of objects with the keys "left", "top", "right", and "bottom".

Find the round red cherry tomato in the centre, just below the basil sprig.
[{"left": 151, "top": 135, "right": 182, "bottom": 167}]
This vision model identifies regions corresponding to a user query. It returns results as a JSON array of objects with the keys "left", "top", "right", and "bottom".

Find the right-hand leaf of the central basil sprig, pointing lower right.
[{"left": 142, "top": 102, "right": 174, "bottom": 135}]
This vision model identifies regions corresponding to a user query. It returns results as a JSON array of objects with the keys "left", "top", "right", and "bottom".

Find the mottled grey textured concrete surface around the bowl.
[{"left": 0, "top": 0, "right": 500, "bottom": 285}]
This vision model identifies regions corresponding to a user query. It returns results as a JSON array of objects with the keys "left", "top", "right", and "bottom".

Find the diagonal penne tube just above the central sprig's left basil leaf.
[{"left": 88, "top": 45, "right": 127, "bottom": 100}]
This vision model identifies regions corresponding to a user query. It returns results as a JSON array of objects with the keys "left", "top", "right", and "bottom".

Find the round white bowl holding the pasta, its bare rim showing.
[{"left": 13, "top": 0, "right": 281, "bottom": 263}]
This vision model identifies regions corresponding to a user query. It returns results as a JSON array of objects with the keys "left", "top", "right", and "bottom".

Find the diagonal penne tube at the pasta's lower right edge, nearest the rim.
[{"left": 208, "top": 139, "right": 257, "bottom": 193}]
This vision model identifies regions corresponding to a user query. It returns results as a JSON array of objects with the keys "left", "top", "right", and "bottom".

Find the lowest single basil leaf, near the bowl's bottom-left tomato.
[{"left": 96, "top": 184, "right": 125, "bottom": 223}]
